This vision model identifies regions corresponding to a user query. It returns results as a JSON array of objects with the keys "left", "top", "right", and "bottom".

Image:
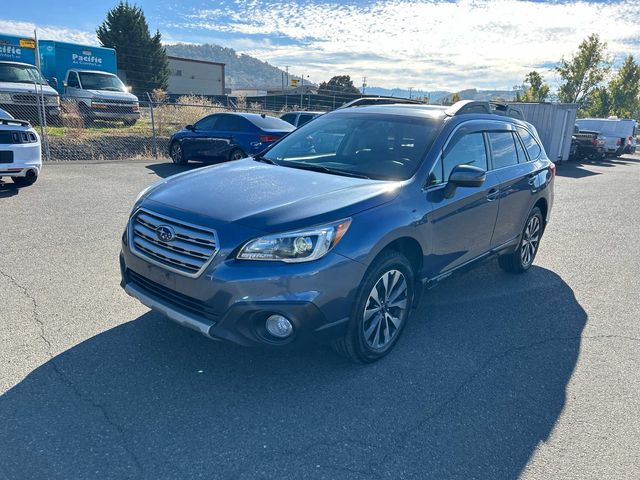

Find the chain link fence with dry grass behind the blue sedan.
[{"left": 0, "top": 88, "right": 412, "bottom": 161}]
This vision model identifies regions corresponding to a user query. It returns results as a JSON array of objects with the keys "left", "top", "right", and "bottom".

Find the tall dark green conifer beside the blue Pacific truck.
[{"left": 96, "top": 1, "right": 169, "bottom": 95}]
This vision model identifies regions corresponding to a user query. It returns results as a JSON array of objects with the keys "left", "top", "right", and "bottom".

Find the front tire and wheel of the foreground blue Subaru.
[{"left": 333, "top": 250, "right": 415, "bottom": 363}]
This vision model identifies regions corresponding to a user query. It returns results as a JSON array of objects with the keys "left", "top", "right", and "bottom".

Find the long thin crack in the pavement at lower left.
[{"left": 0, "top": 270, "right": 144, "bottom": 475}]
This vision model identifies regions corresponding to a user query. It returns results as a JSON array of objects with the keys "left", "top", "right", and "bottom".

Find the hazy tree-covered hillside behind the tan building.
[{"left": 166, "top": 43, "right": 298, "bottom": 88}]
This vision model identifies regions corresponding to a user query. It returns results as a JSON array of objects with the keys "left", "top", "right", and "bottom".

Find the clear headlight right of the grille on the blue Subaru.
[{"left": 237, "top": 218, "right": 351, "bottom": 263}]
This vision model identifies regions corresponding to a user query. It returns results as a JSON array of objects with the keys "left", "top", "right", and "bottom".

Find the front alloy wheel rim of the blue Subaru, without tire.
[{"left": 362, "top": 270, "right": 408, "bottom": 350}]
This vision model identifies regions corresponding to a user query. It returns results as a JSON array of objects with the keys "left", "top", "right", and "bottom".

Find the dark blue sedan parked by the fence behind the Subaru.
[{"left": 169, "top": 113, "right": 295, "bottom": 165}]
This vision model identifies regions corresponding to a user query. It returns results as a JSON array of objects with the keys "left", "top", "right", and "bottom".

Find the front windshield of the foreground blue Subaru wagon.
[{"left": 262, "top": 113, "right": 439, "bottom": 180}]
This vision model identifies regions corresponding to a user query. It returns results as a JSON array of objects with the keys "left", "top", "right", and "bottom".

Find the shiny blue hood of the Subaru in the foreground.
[{"left": 143, "top": 159, "right": 402, "bottom": 232}]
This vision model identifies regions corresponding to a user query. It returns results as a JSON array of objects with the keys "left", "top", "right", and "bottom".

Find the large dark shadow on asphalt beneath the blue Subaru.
[{"left": 0, "top": 263, "right": 587, "bottom": 479}]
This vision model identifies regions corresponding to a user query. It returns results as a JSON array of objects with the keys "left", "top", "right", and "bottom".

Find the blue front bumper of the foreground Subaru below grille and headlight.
[{"left": 120, "top": 245, "right": 366, "bottom": 346}]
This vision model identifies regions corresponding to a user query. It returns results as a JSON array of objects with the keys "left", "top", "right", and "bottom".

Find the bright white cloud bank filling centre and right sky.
[{"left": 178, "top": 0, "right": 640, "bottom": 89}]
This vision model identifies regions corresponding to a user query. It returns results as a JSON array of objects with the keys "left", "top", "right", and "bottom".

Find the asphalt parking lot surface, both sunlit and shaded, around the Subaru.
[{"left": 0, "top": 157, "right": 640, "bottom": 480}]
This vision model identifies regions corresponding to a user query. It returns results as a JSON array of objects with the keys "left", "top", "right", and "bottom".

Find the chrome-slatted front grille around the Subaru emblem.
[{"left": 129, "top": 209, "right": 218, "bottom": 277}]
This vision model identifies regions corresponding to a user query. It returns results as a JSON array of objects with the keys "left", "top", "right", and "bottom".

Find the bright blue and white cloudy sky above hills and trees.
[{"left": 0, "top": 0, "right": 640, "bottom": 91}]
